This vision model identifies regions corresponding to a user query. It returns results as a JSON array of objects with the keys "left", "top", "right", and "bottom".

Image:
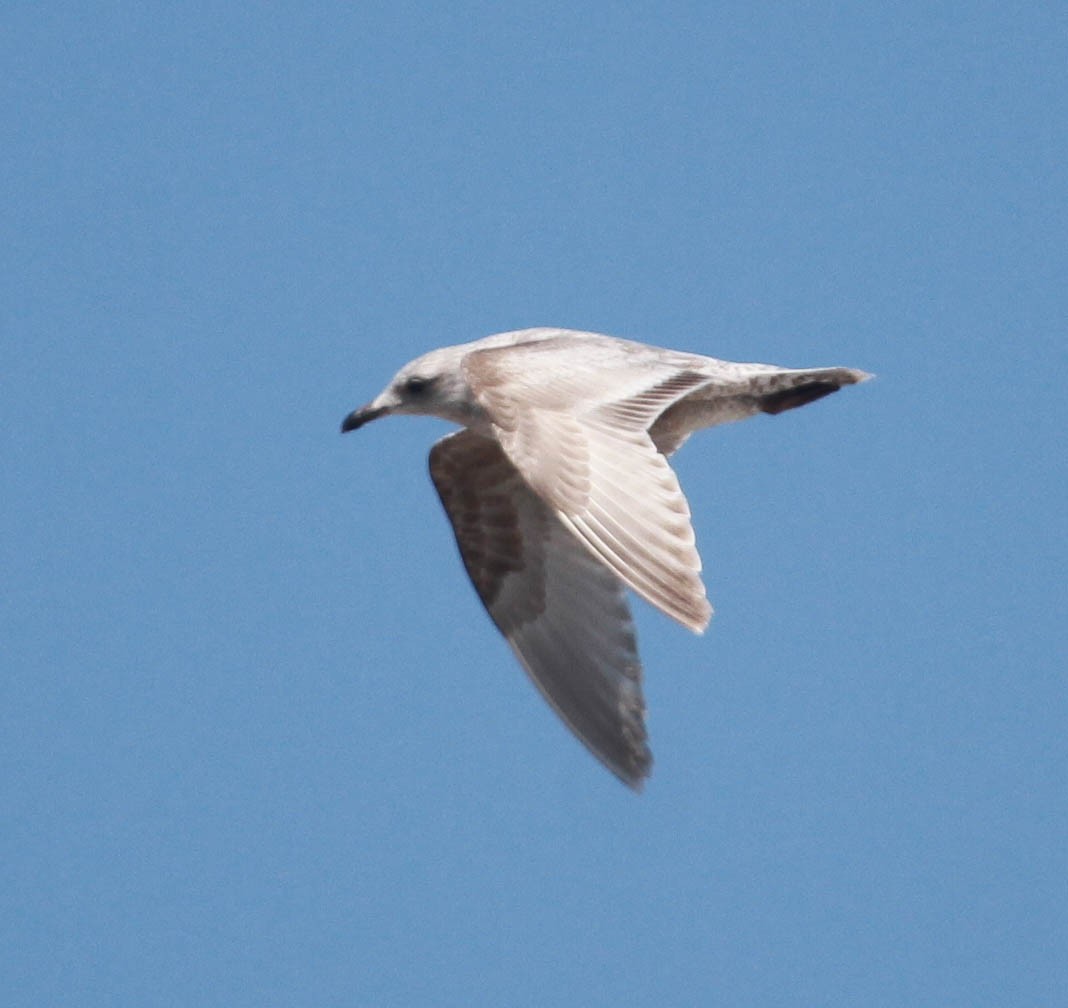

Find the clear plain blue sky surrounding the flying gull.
[{"left": 0, "top": 0, "right": 1068, "bottom": 1008}]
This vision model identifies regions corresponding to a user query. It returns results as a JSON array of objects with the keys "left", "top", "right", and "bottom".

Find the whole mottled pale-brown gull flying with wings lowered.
[{"left": 341, "top": 328, "right": 870, "bottom": 790}]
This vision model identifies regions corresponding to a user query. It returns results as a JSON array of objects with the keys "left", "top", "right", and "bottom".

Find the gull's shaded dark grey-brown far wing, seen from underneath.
[{"left": 430, "top": 430, "right": 651, "bottom": 788}]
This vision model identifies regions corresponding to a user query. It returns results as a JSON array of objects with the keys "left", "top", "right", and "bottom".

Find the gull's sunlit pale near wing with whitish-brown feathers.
[{"left": 464, "top": 336, "right": 712, "bottom": 632}]
